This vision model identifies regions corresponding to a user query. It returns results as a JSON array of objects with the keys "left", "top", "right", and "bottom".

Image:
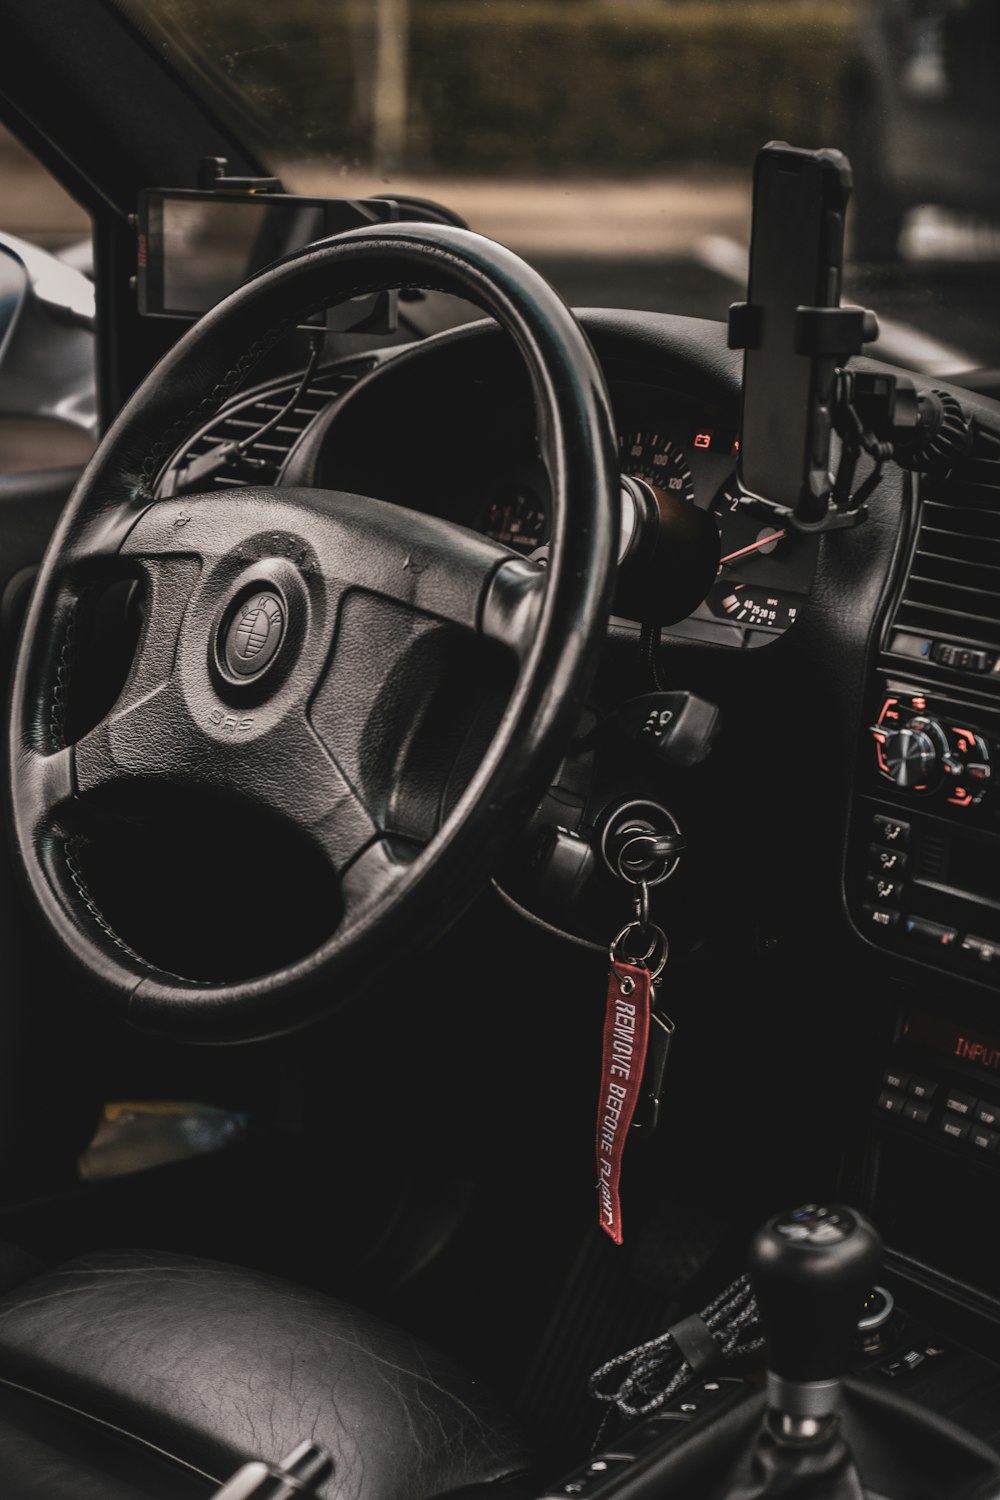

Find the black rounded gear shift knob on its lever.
[{"left": 748, "top": 1203, "right": 882, "bottom": 1419}]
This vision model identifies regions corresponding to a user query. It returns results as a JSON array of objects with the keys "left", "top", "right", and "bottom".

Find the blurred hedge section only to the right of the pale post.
[{"left": 411, "top": 0, "right": 847, "bottom": 173}]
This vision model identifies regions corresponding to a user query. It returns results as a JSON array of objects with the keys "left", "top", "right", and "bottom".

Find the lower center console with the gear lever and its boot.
[{"left": 546, "top": 1203, "right": 1000, "bottom": 1500}]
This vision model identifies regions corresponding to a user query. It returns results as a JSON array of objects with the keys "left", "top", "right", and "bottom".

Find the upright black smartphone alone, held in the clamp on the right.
[{"left": 730, "top": 141, "right": 852, "bottom": 522}]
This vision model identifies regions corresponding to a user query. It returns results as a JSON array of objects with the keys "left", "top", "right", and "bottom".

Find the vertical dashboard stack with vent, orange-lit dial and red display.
[{"left": 827, "top": 447, "right": 1000, "bottom": 1488}]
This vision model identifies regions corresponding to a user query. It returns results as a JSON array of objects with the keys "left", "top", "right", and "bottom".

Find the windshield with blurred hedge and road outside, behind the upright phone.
[{"left": 111, "top": 0, "right": 1000, "bottom": 377}]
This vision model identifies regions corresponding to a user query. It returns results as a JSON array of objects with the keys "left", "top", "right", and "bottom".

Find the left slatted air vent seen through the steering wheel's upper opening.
[{"left": 157, "top": 362, "right": 370, "bottom": 494}]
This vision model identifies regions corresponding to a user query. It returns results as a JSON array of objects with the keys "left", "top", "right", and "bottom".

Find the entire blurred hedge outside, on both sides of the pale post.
[{"left": 138, "top": 0, "right": 861, "bottom": 176}]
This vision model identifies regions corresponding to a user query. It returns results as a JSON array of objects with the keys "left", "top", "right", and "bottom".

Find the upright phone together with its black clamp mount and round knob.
[{"left": 727, "top": 141, "right": 973, "bottom": 533}]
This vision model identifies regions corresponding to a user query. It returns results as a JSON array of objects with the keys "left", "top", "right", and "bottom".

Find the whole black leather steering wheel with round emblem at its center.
[{"left": 9, "top": 224, "right": 619, "bottom": 1041}]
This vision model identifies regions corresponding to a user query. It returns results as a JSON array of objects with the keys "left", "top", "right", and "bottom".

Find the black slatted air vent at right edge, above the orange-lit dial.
[{"left": 895, "top": 431, "right": 1000, "bottom": 654}]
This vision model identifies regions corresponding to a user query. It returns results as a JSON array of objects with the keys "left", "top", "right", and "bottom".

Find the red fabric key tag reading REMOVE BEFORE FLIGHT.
[{"left": 597, "top": 953, "right": 652, "bottom": 1245}]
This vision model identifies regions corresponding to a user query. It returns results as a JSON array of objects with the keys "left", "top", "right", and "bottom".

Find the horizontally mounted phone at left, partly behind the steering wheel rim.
[{"left": 136, "top": 188, "right": 399, "bottom": 333}]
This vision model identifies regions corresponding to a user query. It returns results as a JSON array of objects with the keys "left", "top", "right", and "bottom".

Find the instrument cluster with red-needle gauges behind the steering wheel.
[{"left": 277, "top": 322, "right": 817, "bottom": 648}]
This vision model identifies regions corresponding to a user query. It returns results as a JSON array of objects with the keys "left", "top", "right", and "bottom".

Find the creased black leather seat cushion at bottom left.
[{"left": 0, "top": 1251, "right": 528, "bottom": 1500}]
